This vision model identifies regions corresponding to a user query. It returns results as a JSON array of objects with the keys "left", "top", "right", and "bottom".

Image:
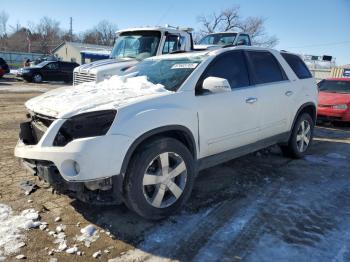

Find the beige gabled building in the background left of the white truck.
[{"left": 52, "top": 42, "right": 112, "bottom": 64}]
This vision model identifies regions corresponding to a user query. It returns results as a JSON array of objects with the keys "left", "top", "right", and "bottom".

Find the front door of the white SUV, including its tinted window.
[{"left": 196, "top": 51, "right": 259, "bottom": 157}]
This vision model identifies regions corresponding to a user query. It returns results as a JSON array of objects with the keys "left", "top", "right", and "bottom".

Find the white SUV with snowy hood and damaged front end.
[{"left": 15, "top": 46, "right": 317, "bottom": 219}]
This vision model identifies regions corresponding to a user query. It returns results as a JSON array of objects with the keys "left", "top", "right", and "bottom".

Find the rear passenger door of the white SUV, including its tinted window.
[{"left": 246, "top": 50, "right": 293, "bottom": 140}]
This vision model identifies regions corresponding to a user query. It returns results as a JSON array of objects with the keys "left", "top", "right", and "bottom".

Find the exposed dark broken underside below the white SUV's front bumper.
[{"left": 22, "top": 159, "right": 123, "bottom": 205}]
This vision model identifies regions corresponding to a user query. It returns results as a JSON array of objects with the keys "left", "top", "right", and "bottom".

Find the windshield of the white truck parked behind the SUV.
[{"left": 111, "top": 31, "right": 161, "bottom": 60}]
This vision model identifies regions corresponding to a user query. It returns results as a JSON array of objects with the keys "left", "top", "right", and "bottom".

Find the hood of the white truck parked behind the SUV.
[{"left": 74, "top": 58, "right": 138, "bottom": 74}]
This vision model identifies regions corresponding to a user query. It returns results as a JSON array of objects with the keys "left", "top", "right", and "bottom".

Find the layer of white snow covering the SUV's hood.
[{"left": 25, "top": 76, "right": 172, "bottom": 118}]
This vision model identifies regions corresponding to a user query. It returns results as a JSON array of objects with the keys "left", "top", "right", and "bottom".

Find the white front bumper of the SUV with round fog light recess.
[{"left": 15, "top": 119, "right": 131, "bottom": 182}]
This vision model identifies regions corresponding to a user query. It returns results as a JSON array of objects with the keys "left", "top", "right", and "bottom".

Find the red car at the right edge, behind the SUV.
[{"left": 317, "top": 78, "right": 350, "bottom": 122}]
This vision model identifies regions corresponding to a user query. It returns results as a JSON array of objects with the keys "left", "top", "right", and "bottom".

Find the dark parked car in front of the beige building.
[{"left": 17, "top": 61, "right": 79, "bottom": 83}]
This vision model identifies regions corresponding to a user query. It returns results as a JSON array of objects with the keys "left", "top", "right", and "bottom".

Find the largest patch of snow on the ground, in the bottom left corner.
[{"left": 0, "top": 204, "right": 40, "bottom": 257}]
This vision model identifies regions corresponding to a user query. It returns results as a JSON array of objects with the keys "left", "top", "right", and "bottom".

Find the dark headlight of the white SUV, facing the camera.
[{"left": 53, "top": 110, "right": 117, "bottom": 146}]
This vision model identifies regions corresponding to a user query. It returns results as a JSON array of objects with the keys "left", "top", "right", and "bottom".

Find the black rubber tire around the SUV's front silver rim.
[{"left": 125, "top": 138, "right": 195, "bottom": 220}]
